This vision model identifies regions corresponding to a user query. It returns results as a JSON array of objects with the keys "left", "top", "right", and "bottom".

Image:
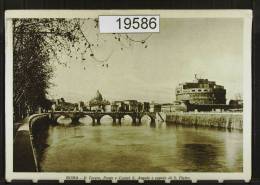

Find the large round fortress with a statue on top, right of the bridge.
[{"left": 175, "top": 76, "right": 226, "bottom": 105}]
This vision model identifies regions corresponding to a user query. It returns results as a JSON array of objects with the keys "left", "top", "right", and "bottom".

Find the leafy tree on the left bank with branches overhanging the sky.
[{"left": 13, "top": 18, "right": 151, "bottom": 119}]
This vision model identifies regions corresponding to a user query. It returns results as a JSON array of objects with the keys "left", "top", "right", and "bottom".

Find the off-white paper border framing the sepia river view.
[{"left": 5, "top": 10, "right": 252, "bottom": 182}]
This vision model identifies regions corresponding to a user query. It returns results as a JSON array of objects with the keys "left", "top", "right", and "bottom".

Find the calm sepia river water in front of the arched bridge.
[{"left": 40, "top": 116, "right": 243, "bottom": 172}]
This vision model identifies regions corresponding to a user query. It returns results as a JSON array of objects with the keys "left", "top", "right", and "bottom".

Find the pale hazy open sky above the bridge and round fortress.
[{"left": 49, "top": 18, "right": 243, "bottom": 103}]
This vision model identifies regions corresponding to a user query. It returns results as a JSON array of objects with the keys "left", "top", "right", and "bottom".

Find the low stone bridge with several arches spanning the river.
[{"left": 51, "top": 111, "right": 156, "bottom": 125}]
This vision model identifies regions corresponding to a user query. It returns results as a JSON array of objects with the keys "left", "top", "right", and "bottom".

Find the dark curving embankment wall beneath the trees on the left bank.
[{"left": 13, "top": 114, "right": 50, "bottom": 172}]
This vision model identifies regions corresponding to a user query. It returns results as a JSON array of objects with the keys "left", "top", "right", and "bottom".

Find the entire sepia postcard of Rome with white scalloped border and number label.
[{"left": 5, "top": 10, "right": 252, "bottom": 182}]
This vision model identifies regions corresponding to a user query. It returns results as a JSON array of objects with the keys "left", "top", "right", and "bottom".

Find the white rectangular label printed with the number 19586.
[{"left": 99, "top": 15, "right": 160, "bottom": 33}]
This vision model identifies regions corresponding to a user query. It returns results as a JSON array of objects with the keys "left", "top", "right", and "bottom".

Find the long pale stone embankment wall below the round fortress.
[{"left": 166, "top": 112, "right": 243, "bottom": 130}]
